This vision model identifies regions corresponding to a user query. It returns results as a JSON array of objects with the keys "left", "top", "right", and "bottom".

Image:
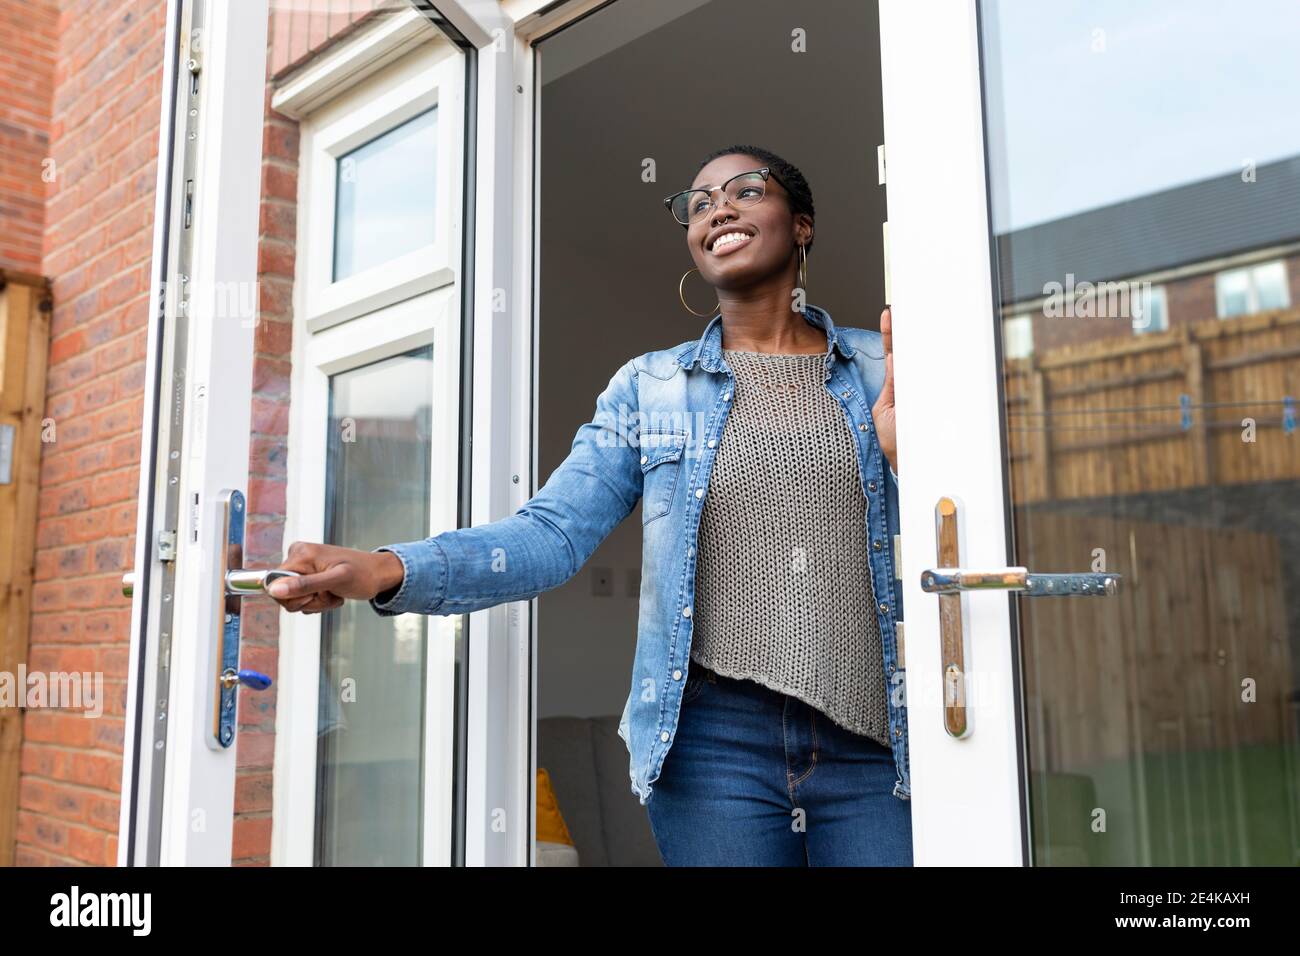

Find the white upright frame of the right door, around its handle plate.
[{"left": 880, "top": 0, "right": 1028, "bottom": 866}]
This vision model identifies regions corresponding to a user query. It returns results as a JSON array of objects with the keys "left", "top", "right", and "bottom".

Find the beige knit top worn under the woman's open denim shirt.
[{"left": 690, "top": 349, "right": 889, "bottom": 747}]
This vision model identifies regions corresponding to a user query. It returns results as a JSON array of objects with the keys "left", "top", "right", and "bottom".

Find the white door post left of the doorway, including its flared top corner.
[{"left": 457, "top": 0, "right": 660, "bottom": 866}]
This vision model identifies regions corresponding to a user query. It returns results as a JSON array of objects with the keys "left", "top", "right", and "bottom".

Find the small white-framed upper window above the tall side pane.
[{"left": 298, "top": 44, "right": 464, "bottom": 334}]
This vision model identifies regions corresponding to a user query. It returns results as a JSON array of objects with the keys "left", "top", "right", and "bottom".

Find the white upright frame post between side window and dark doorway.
[{"left": 436, "top": 0, "right": 533, "bottom": 866}]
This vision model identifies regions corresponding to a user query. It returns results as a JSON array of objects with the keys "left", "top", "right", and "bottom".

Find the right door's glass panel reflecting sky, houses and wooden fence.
[{"left": 980, "top": 0, "right": 1300, "bottom": 865}]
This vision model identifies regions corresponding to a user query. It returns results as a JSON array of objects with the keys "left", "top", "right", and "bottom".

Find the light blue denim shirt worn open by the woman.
[{"left": 371, "top": 306, "right": 911, "bottom": 804}]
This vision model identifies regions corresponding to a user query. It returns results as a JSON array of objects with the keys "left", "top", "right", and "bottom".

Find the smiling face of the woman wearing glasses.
[{"left": 686, "top": 153, "right": 813, "bottom": 290}]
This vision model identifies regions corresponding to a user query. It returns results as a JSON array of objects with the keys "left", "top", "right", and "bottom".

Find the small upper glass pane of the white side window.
[{"left": 334, "top": 108, "right": 438, "bottom": 282}]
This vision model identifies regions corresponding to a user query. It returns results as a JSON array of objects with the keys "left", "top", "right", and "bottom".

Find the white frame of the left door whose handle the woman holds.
[{"left": 118, "top": 0, "right": 267, "bottom": 865}]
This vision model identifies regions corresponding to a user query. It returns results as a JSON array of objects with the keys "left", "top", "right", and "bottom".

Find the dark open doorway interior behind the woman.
[{"left": 534, "top": 0, "right": 885, "bottom": 866}]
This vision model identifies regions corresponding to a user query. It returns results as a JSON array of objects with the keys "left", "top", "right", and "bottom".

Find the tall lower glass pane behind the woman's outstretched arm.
[{"left": 316, "top": 347, "right": 433, "bottom": 866}]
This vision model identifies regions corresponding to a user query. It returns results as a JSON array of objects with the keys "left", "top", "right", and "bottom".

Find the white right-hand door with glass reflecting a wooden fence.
[{"left": 880, "top": 0, "right": 1300, "bottom": 865}]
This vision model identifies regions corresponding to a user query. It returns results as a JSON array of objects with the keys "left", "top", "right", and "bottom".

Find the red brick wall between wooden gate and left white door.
[{"left": 17, "top": 0, "right": 166, "bottom": 865}]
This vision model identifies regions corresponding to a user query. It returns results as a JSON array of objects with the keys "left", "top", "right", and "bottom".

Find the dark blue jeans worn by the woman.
[{"left": 646, "top": 661, "right": 911, "bottom": 866}]
